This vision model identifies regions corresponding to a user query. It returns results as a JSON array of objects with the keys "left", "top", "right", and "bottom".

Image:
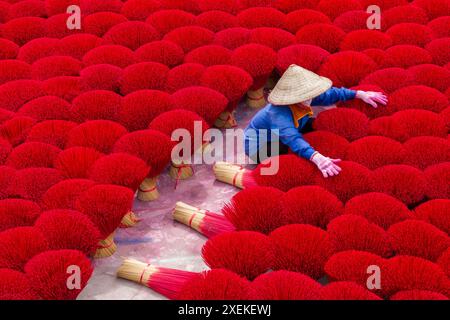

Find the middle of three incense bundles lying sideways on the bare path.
[{"left": 172, "top": 202, "right": 236, "bottom": 238}]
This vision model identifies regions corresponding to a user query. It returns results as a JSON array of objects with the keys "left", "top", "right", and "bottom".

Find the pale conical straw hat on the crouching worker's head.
[{"left": 268, "top": 64, "right": 333, "bottom": 105}]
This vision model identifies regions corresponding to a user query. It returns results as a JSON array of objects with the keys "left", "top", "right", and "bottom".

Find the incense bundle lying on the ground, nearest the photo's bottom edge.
[{"left": 117, "top": 259, "right": 197, "bottom": 299}]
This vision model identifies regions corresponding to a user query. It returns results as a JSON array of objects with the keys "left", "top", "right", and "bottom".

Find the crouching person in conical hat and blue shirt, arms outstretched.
[{"left": 245, "top": 65, "right": 387, "bottom": 178}]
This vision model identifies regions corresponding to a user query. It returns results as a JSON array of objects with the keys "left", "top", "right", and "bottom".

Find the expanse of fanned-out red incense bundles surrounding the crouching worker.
[{"left": 0, "top": 0, "right": 450, "bottom": 300}]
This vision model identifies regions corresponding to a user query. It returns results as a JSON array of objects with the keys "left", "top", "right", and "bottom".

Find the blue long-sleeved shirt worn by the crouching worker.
[{"left": 245, "top": 87, "right": 356, "bottom": 159}]
